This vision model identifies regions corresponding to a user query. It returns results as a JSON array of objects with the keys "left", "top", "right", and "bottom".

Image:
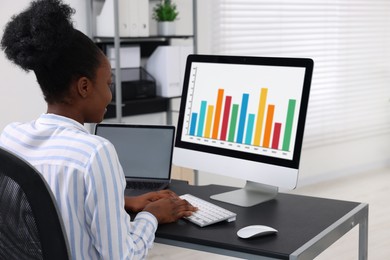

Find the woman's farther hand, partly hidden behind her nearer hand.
[{"left": 125, "top": 190, "right": 179, "bottom": 212}]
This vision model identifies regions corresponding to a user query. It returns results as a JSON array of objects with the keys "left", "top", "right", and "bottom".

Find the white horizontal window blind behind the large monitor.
[{"left": 211, "top": 0, "right": 390, "bottom": 148}]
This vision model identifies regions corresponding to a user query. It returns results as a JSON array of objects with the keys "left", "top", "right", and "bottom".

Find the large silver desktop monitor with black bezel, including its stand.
[{"left": 173, "top": 55, "right": 313, "bottom": 206}]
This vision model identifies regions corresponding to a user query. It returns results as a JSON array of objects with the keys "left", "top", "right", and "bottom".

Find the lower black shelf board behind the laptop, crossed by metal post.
[{"left": 104, "top": 97, "right": 170, "bottom": 119}]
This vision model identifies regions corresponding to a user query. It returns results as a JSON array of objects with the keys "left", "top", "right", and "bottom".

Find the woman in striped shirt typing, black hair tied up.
[{"left": 0, "top": 0, "right": 195, "bottom": 259}]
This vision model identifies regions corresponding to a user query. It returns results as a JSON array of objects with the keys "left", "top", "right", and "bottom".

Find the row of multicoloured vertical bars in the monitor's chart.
[{"left": 189, "top": 88, "right": 296, "bottom": 151}]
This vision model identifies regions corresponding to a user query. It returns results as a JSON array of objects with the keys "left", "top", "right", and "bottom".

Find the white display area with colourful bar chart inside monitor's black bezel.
[{"left": 183, "top": 64, "right": 304, "bottom": 158}]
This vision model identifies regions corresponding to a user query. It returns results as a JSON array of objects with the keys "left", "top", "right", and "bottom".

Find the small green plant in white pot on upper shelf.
[{"left": 153, "top": 0, "right": 179, "bottom": 35}]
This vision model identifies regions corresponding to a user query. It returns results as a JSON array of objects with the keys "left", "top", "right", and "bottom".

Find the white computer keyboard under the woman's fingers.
[{"left": 180, "top": 194, "right": 237, "bottom": 227}]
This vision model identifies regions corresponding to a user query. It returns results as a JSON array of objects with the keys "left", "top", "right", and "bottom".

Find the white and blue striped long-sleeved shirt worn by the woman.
[{"left": 0, "top": 114, "right": 157, "bottom": 259}]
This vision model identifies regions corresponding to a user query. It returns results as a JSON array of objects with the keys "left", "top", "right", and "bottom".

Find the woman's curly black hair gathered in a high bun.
[{"left": 1, "top": 0, "right": 103, "bottom": 103}]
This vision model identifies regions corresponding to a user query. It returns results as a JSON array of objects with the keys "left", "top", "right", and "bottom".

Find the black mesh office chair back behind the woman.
[{"left": 0, "top": 148, "right": 71, "bottom": 260}]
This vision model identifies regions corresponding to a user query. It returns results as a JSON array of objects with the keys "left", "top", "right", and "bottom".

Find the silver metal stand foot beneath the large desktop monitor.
[{"left": 210, "top": 181, "right": 278, "bottom": 207}]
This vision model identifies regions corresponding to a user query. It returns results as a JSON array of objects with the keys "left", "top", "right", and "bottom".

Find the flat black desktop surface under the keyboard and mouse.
[{"left": 149, "top": 182, "right": 366, "bottom": 259}]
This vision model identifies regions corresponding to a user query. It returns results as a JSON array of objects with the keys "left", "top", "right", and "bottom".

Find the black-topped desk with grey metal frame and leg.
[{"left": 156, "top": 182, "right": 368, "bottom": 260}]
